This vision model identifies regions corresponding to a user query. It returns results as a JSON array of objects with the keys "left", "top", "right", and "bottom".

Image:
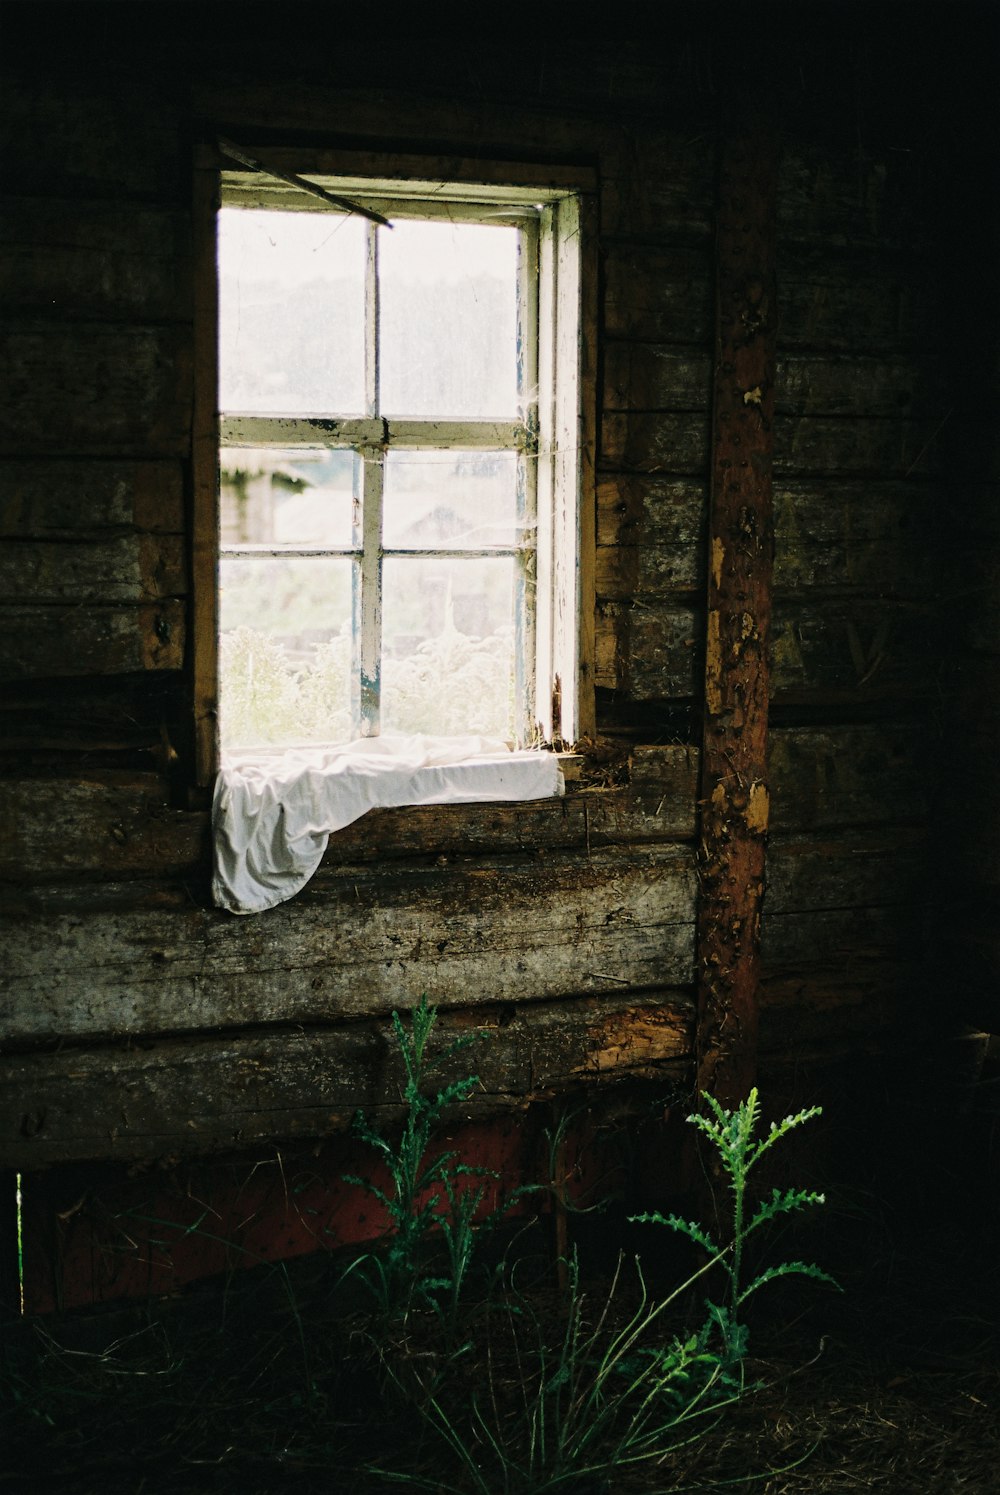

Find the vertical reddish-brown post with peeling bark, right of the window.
[{"left": 697, "top": 126, "right": 777, "bottom": 1105}]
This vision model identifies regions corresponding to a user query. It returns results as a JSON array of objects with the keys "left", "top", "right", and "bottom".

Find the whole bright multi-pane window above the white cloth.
[{"left": 196, "top": 152, "right": 592, "bottom": 776}]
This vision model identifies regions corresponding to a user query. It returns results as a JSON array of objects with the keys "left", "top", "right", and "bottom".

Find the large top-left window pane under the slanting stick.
[{"left": 218, "top": 208, "right": 365, "bottom": 416}]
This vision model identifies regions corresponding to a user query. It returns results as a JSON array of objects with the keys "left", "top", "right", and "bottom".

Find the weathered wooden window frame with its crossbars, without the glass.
[{"left": 191, "top": 147, "right": 596, "bottom": 785}]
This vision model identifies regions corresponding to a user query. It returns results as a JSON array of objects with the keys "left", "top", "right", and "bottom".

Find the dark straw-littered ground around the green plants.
[{"left": 0, "top": 1190, "right": 1000, "bottom": 1495}]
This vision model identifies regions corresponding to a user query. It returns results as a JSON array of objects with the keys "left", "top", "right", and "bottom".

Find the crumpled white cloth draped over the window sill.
[{"left": 212, "top": 736, "right": 565, "bottom": 913}]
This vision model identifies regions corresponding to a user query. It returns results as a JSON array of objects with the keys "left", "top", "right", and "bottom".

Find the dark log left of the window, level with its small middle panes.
[{"left": 0, "top": 457, "right": 184, "bottom": 540}]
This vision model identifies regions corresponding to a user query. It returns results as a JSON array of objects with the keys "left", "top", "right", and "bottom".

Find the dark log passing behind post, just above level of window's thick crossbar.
[{"left": 604, "top": 341, "right": 946, "bottom": 428}]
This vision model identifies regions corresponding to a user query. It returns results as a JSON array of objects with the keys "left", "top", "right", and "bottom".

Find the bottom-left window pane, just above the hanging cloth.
[{"left": 218, "top": 556, "right": 354, "bottom": 750}]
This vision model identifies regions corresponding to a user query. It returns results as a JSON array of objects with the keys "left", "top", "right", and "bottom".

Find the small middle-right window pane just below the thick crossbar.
[{"left": 383, "top": 450, "right": 517, "bottom": 550}]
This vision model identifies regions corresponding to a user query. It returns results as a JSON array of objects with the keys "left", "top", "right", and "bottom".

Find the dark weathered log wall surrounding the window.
[{"left": 0, "top": 7, "right": 1000, "bottom": 1303}]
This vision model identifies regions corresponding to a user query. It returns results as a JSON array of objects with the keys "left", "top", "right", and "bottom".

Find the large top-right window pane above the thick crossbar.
[{"left": 378, "top": 218, "right": 517, "bottom": 420}]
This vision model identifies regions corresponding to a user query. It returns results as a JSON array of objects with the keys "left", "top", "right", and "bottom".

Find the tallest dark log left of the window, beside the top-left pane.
[{"left": 0, "top": 323, "right": 191, "bottom": 457}]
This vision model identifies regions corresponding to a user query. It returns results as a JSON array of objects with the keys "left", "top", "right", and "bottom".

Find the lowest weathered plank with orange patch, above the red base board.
[{"left": 0, "top": 991, "right": 692, "bottom": 1172}]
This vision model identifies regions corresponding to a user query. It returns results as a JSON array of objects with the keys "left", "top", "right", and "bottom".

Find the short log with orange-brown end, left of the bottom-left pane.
[{"left": 0, "top": 598, "right": 185, "bottom": 680}]
